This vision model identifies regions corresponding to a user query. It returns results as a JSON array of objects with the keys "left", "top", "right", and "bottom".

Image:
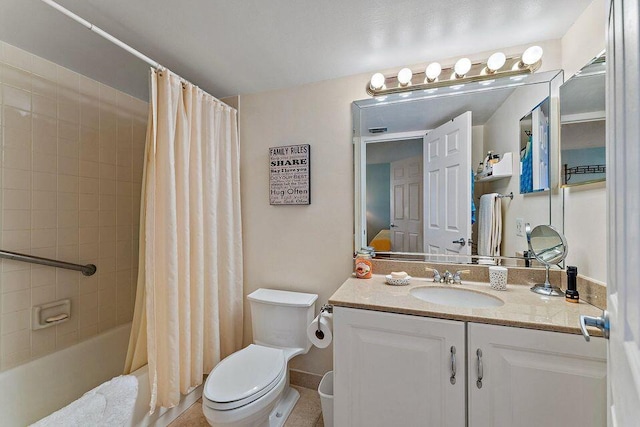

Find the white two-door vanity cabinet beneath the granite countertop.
[{"left": 334, "top": 307, "right": 606, "bottom": 427}]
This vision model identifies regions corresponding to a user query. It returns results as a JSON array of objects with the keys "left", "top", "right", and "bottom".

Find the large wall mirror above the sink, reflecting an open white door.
[{"left": 352, "top": 71, "right": 562, "bottom": 262}]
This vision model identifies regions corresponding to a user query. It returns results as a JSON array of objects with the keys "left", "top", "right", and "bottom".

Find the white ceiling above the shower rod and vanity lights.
[{"left": 0, "top": 0, "right": 591, "bottom": 98}]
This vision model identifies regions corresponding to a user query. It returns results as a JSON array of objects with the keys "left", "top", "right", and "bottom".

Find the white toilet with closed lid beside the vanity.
[{"left": 202, "top": 289, "right": 318, "bottom": 427}]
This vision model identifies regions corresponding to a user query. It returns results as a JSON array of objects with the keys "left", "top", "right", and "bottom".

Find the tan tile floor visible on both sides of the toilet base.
[{"left": 169, "top": 386, "right": 324, "bottom": 427}]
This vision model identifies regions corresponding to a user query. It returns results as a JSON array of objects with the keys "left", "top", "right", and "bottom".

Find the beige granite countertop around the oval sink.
[{"left": 329, "top": 274, "right": 602, "bottom": 336}]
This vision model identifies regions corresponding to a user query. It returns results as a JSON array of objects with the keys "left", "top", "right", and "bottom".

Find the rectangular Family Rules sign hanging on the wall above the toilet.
[{"left": 269, "top": 144, "right": 311, "bottom": 205}]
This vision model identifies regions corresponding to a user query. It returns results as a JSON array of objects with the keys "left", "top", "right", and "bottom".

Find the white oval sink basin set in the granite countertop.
[{"left": 409, "top": 286, "right": 504, "bottom": 308}]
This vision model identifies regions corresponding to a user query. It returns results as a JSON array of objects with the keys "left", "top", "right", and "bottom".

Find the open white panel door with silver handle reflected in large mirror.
[{"left": 423, "top": 111, "right": 471, "bottom": 255}]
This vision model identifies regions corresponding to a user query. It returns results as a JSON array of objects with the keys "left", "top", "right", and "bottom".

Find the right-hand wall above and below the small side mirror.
[{"left": 561, "top": 0, "right": 607, "bottom": 282}]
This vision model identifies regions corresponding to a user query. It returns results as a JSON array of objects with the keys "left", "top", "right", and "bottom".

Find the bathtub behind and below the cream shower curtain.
[{"left": 0, "top": 324, "right": 202, "bottom": 427}]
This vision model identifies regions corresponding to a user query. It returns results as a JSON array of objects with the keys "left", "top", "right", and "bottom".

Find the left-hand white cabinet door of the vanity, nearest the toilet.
[{"left": 333, "top": 307, "right": 466, "bottom": 427}]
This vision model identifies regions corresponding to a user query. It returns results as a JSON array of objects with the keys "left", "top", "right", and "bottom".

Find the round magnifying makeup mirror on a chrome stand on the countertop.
[{"left": 525, "top": 223, "right": 569, "bottom": 296}]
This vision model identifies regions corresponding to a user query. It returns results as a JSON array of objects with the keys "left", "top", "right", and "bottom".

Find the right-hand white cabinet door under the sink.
[{"left": 467, "top": 323, "right": 607, "bottom": 427}]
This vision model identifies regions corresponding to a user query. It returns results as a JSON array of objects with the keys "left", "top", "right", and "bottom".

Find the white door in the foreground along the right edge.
[{"left": 607, "top": 0, "right": 640, "bottom": 427}]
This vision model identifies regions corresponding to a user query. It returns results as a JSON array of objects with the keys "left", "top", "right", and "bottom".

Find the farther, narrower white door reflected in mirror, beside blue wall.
[{"left": 389, "top": 156, "right": 422, "bottom": 252}]
